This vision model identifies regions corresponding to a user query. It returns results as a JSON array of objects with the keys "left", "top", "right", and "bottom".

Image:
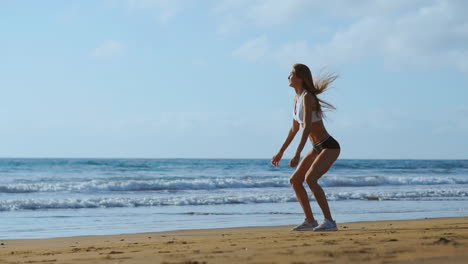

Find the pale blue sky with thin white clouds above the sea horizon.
[{"left": 0, "top": 0, "right": 468, "bottom": 159}]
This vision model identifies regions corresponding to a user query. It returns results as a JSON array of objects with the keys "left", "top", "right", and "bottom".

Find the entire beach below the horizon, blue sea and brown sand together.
[{"left": 0, "top": 158, "right": 468, "bottom": 264}]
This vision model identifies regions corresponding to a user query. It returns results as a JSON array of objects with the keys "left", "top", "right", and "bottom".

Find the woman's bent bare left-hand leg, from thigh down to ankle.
[{"left": 289, "top": 150, "right": 317, "bottom": 222}]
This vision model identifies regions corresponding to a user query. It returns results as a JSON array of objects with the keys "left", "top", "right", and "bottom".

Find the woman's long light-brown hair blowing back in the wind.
[{"left": 293, "top": 63, "right": 338, "bottom": 117}]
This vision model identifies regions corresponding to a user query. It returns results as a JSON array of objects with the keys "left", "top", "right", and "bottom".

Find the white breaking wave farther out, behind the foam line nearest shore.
[{"left": 0, "top": 176, "right": 468, "bottom": 193}]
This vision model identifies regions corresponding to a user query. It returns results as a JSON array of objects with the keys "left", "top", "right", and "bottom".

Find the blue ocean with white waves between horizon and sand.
[{"left": 0, "top": 158, "right": 468, "bottom": 239}]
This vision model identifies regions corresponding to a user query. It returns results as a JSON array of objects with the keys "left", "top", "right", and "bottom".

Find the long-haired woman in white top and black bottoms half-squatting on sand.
[{"left": 271, "top": 64, "right": 340, "bottom": 231}]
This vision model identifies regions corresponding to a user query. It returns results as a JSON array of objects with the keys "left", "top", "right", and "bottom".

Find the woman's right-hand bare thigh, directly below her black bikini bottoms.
[{"left": 305, "top": 149, "right": 340, "bottom": 183}]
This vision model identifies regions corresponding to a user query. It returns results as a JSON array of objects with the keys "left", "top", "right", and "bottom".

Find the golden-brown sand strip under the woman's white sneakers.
[{"left": 0, "top": 217, "right": 468, "bottom": 264}]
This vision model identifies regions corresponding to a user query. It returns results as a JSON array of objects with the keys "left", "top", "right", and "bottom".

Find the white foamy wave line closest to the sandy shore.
[{"left": 0, "top": 189, "right": 468, "bottom": 211}]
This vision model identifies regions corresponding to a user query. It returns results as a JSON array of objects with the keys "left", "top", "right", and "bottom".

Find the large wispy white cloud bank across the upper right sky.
[{"left": 228, "top": 0, "right": 468, "bottom": 74}]
